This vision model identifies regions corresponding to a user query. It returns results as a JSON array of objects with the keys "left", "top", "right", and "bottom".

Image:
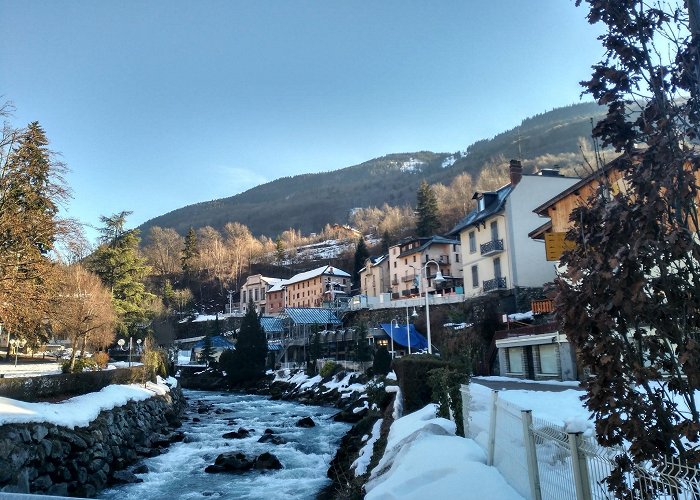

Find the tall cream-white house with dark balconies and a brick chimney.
[{"left": 448, "top": 160, "right": 579, "bottom": 297}]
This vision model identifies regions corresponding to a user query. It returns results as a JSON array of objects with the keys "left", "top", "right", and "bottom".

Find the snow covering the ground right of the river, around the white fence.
[{"left": 364, "top": 377, "right": 593, "bottom": 500}]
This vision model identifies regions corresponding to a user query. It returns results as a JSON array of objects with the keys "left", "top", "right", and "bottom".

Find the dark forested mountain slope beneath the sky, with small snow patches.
[{"left": 140, "top": 103, "right": 602, "bottom": 238}]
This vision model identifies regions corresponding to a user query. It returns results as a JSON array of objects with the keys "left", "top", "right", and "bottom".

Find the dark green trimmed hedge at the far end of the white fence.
[{"left": 394, "top": 354, "right": 447, "bottom": 413}]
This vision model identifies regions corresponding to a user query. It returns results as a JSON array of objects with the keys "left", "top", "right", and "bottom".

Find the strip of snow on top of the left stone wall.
[{"left": 0, "top": 377, "right": 177, "bottom": 429}]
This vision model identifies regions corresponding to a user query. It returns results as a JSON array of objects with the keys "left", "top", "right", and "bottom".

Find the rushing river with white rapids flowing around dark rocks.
[{"left": 98, "top": 391, "right": 349, "bottom": 500}]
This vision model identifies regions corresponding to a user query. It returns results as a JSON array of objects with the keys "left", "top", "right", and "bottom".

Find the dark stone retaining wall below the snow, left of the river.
[{"left": 0, "top": 387, "right": 185, "bottom": 497}]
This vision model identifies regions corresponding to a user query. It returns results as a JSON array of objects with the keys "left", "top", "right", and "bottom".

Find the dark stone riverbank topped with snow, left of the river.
[{"left": 0, "top": 379, "right": 184, "bottom": 497}]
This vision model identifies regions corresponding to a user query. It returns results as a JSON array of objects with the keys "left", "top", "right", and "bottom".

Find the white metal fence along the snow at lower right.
[{"left": 462, "top": 385, "right": 700, "bottom": 500}]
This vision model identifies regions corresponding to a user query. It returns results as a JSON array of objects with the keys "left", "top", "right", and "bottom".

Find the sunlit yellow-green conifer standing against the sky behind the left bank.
[{"left": 86, "top": 212, "right": 153, "bottom": 336}]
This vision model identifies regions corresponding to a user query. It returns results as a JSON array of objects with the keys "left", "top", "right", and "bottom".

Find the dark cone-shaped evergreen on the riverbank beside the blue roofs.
[{"left": 221, "top": 302, "right": 267, "bottom": 382}]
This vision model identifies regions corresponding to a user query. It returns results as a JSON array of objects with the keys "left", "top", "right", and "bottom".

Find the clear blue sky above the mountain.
[{"left": 0, "top": 0, "right": 603, "bottom": 240}]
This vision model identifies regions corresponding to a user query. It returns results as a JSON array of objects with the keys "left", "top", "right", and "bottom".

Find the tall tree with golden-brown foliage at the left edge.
[{"left": 0, "top": 121, "right": 69, "bottom": 342}]
